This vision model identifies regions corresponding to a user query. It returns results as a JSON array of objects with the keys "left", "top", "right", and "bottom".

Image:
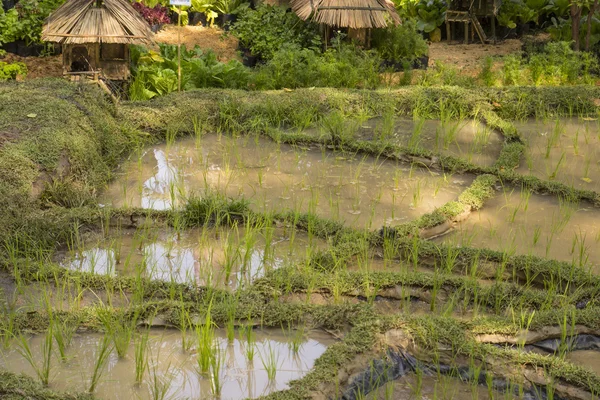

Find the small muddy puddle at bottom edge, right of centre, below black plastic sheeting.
[{"left": 365, "top": 374, "right": 503, "bottom": 400}]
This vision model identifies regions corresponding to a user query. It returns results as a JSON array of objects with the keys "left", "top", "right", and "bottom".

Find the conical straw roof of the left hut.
[{"left": 42, "top": 0, "right": 154, "bottom": 44}]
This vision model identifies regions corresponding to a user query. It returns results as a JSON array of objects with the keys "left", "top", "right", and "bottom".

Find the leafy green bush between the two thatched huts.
[{"left": 231, "top": 5, "right": 321, "bottom": 61}]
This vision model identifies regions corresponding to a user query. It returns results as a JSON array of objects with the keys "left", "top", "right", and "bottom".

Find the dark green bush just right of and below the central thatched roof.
[{"left": 372, "top": 20, "right": 429, "bottom": 63}]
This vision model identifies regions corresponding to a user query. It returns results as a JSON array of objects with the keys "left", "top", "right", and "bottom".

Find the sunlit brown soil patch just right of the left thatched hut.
[{"left": 154, "top": 25, "right": 239, "bottom": 62}]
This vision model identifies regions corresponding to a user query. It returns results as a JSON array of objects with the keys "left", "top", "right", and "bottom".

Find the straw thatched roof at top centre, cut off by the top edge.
[{"left": 291, "top": 0, "right": 400, "bottom": 29}]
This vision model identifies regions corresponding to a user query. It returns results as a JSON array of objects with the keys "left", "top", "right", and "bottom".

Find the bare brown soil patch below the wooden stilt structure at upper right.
[{"left": 429, "top": 39, "right": 522, "bottom": 74}]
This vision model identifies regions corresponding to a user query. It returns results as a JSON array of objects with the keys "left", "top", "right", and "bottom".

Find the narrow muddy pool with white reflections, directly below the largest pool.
[{"left": 58, "top": 226, "right": 326, "bottom": 288}]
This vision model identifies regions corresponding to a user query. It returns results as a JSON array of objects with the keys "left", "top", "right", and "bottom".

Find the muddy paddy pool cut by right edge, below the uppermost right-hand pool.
[{"left": 435, "top": 188, "right": 600, "bottom": 266}]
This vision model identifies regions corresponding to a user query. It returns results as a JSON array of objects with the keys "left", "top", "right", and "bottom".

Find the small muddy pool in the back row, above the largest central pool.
[{"left": 359, "top": 118, "right": 503, "bottom": 166}]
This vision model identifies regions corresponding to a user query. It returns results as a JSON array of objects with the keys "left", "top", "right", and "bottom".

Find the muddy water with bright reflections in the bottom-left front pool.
[{"left": 0, "top": 330, "right": 333, "bottom": 400}]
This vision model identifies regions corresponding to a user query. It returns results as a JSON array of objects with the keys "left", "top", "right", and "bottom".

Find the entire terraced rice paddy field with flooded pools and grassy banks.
[{"left": 0, "top": 79, "right": 600, "bottom": 400}]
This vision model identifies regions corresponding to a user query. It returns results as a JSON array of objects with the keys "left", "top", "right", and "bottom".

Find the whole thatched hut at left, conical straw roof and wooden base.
[{"left": 42, "top": 0, "right": 153, "bottom": 80}]
